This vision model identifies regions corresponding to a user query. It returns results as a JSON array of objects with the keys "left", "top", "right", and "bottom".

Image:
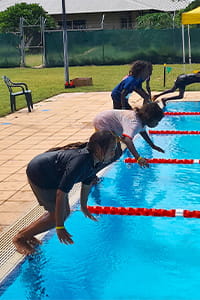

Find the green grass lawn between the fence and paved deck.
[{"left": 0, "top": 64, "right": 200, "bottom": 116}]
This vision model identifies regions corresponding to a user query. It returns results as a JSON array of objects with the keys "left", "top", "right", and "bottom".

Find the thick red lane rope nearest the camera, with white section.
[{"left": 87, "top": 206, "right": 200, "bottom": 218}]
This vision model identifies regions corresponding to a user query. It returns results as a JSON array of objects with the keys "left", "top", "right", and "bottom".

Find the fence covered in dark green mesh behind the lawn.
[{"left": 0, "top": 28, "right": 200, "bottom": 67}]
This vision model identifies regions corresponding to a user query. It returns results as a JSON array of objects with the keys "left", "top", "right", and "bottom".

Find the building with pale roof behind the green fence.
[{"left": 0, "top": 0, "right": 192, "bottom": 30}]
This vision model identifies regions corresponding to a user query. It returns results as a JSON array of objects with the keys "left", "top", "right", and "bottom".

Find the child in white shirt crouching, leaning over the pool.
[{"left": 93, "top": 103, "right": 165, "bottom": 168}]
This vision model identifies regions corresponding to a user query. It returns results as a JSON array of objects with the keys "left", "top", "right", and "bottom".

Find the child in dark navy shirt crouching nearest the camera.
[{"left": 13, "top": 130, "right": 122, "bottom": 255}]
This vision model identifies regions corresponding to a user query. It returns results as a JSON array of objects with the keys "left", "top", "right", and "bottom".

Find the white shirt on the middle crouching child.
[{"left": 93, "top": 109, "right": 145, "bottom": 139}]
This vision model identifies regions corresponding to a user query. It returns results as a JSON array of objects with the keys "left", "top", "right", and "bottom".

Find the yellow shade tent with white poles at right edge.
[{"left": 182, "top": 6, "right": 200, "bottom": 64}]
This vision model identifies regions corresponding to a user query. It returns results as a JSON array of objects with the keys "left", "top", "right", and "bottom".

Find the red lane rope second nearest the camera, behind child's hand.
[{"left": 124, "top": 157, "right": 200, "bottom": 164}]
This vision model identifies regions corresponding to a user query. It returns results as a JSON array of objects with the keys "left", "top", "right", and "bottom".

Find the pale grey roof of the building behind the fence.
[{"left": 0, "top": 0, "right": 192, "bottom": 15}]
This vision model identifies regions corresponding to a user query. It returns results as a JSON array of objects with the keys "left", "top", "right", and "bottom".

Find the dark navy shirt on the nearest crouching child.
[{"left": 26, "top": 148, "right": 121, "bottom": 193}]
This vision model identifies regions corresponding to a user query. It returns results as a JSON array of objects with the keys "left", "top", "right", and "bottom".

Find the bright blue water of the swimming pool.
[{"left": 0, "top": 102, "right": 200, "bottom": 300}]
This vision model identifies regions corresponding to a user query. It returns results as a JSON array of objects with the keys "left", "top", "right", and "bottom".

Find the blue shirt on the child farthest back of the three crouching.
[{"left": 112, "top": 76, "right": 143, "bottom": 101}]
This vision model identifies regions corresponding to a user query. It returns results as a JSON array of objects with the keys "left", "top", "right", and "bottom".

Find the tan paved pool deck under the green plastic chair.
[{"left": 0, "top": 92, "right": 200, "bottom": 234}]
